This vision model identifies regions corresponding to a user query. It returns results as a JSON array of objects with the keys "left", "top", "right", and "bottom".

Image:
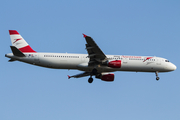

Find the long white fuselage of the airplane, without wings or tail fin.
[{"left": 6, "top": 53, "right": 176, "bottom": 72}]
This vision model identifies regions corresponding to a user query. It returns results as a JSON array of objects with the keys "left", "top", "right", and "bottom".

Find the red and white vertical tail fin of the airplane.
[{"left": 9, "top": 30, "right": 36, "bottom": 53}]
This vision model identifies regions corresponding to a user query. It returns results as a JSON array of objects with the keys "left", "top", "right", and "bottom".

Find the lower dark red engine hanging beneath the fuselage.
[{"left": 96, "top": 73, "right": 114, "bottom": 82}]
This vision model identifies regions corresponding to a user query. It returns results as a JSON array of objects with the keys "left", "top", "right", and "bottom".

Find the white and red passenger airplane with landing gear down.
[{"left": 5, "top": 30, "right": 176, "bottom": 83}]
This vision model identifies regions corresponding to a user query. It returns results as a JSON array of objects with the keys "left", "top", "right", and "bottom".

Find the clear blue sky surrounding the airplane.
[{"left": 0, "top": 0, "right": 180, "bottom": 120}]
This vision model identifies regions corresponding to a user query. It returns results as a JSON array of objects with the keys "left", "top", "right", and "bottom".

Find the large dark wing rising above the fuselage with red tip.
[{"left": 83, "top": 34, "right": 107, "bottom": 65}]
